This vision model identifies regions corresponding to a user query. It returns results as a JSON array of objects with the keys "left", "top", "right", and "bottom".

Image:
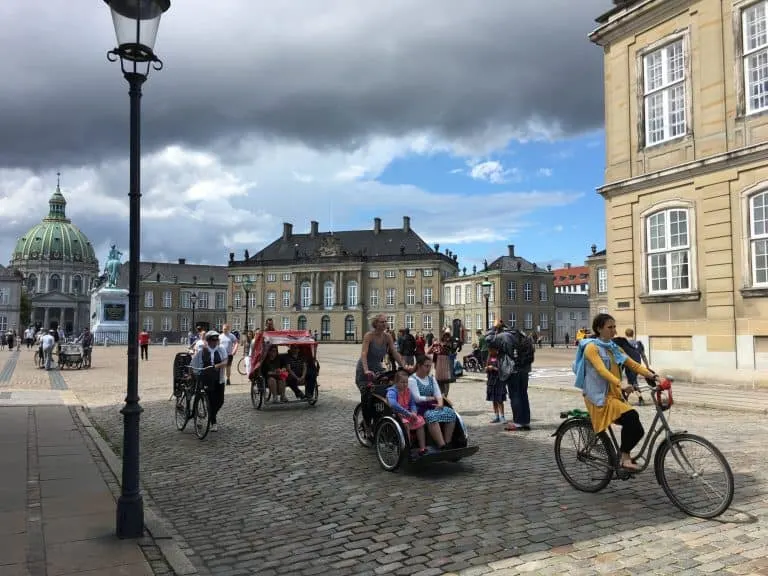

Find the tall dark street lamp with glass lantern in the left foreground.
[{"left": 104, "top": 0, "right": 171, "bottom": 538}]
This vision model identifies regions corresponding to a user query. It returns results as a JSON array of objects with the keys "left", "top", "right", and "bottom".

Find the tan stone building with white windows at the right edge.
[{"left": 590, "top": 0, "right": 768, "bottom": 384}]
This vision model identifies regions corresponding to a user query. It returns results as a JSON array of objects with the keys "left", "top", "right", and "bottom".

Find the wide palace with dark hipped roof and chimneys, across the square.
[{"left": 228, "top": 216, "right": 458, "bottom": 342}]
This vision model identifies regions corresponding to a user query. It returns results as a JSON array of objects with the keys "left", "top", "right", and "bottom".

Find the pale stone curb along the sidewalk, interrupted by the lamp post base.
[{"left": 75, "top": 406, "right": 199, "bottom": 576}]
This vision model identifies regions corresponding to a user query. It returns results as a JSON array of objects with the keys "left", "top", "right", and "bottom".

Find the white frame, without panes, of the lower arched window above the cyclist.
[{"left": 641, "top": 200, "right": 697, "bottom": 296}]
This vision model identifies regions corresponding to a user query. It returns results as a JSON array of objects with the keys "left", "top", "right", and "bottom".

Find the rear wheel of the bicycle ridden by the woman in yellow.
[{"left": 555, "top": 418, "right": 615, "bottom": 492}]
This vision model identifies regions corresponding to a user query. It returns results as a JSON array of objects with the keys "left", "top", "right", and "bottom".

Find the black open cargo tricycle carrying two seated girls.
[{"left": 352, "top": 370, "right": 480, "bottom": 472}]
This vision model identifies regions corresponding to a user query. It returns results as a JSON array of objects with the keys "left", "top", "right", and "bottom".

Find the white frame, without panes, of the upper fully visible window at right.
[{"left": 640, "top": 34, "right": 690, "bottom": 148}]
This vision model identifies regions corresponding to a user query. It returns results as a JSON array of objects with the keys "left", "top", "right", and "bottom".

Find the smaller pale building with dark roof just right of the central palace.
[{"left": 443, "top": 245, "right": 555, "bottom": 342}]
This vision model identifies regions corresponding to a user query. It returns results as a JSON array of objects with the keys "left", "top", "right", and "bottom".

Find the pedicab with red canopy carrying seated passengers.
[{"left": 248, "top": 330, "right": 320, "bottom": 410}]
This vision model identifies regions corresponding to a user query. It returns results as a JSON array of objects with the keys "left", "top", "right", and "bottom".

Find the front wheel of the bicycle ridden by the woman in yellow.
[{"left": 655, "top": 433, "right": 734, "bottom": 519}]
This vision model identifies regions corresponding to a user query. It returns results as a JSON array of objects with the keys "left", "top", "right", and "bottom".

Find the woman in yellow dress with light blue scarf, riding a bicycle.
[{"left": 575, "top": 314, "right": 658, "bottom": 470}]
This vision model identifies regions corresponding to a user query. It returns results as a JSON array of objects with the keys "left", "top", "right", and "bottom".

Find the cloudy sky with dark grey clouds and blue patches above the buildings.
[{"left": 0, "top": 0, "right": 610, "bottom": 267}]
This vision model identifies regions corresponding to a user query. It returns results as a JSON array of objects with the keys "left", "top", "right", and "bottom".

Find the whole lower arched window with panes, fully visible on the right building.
[{"left": 646, "top": 208, "right": 691, "bottom": 294}]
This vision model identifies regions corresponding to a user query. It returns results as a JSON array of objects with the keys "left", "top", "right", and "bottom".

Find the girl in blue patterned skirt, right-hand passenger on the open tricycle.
[{"left": 408, "top": 356, "right": 456, "bottom": 450}]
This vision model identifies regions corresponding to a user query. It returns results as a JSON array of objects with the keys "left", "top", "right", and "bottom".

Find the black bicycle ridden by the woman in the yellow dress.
[{"left": 552, "top": 378, "right": 734, "bottom": 519}]
